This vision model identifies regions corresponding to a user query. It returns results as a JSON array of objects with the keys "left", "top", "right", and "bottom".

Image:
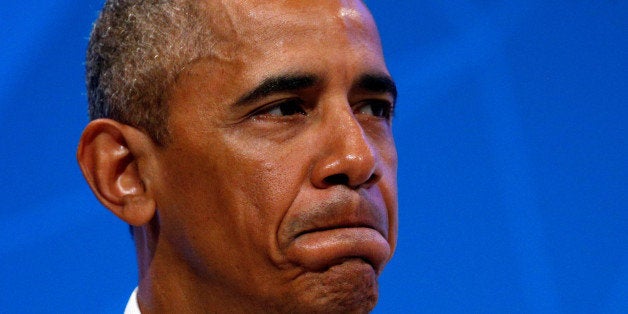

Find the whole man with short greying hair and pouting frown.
[{"left": 77, "top": 0, "right": 397, "bottom": 313}]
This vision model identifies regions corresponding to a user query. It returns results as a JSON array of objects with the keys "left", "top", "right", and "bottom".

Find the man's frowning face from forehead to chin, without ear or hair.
[{"left": 147, "top": 1, "right": 397, "bottom": 312}]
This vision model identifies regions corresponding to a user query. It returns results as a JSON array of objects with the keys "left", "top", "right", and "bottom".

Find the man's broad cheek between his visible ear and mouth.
[{"left": 153, "top": 141, "right": 303, "bottom": 289}]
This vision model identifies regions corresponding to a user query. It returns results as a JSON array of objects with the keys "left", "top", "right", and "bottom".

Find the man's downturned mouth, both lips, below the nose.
[{"left": 285, "top": 195, "right": 391, "bottom": 274}]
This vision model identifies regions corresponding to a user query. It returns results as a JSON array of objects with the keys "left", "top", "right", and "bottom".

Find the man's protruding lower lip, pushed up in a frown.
[{"left": 287, "top": 227, "right": 390, "bottom": 273}]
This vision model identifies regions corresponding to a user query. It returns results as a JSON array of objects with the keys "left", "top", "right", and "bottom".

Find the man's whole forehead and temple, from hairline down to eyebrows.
[{"left": 163, "top": 0, "right": 387, "bottom": 113}]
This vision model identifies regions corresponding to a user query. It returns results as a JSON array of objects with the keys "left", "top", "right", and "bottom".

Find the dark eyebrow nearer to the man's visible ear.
[{"left": 235, "top": 74, "right": 319, "bottom": 106}]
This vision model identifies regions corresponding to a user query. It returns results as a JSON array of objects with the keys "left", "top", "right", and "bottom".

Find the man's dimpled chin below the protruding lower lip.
[{"left": 288, "top": 260, "right": 378, "bottom": 313}]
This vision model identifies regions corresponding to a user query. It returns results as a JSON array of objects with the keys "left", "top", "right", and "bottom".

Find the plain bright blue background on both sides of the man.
[{"left": 0, "top": 0, "right": 628, "bottom": 313}]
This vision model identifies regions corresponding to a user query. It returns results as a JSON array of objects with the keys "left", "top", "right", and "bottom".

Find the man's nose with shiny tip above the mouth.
[{"left": 311, "top": 106, "right": 381, "bottom": 190}]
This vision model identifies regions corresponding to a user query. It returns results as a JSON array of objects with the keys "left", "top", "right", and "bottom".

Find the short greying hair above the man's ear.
[{"left": 85, "top": 0, "right": 212, "bottom": 145}]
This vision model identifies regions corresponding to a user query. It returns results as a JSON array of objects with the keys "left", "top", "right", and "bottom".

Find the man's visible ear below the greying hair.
[{"left": 76, "top": 119, "right": 156, "bottom": 226}]
